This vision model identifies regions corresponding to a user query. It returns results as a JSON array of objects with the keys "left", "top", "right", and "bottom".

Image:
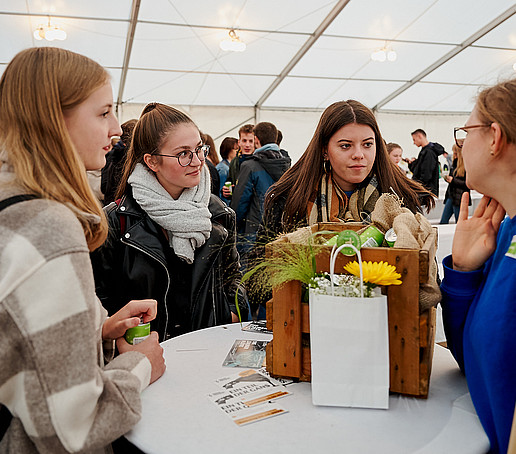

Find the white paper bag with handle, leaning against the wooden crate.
[{"left": 309, "top": 243, "right": 389, "bottom": 408}]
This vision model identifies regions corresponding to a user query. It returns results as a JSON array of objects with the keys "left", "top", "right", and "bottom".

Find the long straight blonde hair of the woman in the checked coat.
[{"left": 0, "top": 47, "right": 109, "bottom": 250}]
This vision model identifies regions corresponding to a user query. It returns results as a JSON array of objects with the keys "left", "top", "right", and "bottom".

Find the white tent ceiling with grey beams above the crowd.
[{"left": 0, "top": 0, "right": 516, "bottom": 112}]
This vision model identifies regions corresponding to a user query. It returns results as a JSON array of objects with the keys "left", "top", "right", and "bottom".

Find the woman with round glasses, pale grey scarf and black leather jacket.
[{"left": 92, "top": 103, "right": 247, "bottom": 340}]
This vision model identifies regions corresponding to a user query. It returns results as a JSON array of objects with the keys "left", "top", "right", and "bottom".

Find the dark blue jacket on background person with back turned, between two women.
[{"left": 231, "top": 144, "right": 291, "bottom": 237}]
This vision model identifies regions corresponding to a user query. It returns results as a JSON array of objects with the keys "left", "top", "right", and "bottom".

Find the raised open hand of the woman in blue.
[{"left": 452, "top": 192, "right": 505, "bottom": 271}]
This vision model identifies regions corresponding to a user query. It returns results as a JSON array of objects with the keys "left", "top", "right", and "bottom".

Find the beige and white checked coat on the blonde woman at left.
[{"left": 0, "top": 179, "right": 151, "bottom": 453}]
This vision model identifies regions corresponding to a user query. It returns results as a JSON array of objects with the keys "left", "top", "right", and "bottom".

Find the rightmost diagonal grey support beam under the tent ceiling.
[{"left": 373, "top": 5, "right": 516, "bottom": 112}]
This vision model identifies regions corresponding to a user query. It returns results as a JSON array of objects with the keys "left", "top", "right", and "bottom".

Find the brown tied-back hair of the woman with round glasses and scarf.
[{"left": 116, "top": 102, "right": 195, "bottom": 198}]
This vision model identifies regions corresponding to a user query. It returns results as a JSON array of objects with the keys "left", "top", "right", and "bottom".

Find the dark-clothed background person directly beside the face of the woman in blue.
[{"left": 439, "top": 142, "right": 471, "bottom": 224}]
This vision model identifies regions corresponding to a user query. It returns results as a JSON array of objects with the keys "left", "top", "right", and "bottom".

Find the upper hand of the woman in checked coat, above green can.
[{"left": 102, "top": 300, "right": 158, "bottom": 340}]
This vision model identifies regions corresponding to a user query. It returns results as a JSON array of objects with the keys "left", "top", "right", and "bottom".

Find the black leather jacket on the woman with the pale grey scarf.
[{"left": 91, "top": 189, "right": 248, "bottom": 341}]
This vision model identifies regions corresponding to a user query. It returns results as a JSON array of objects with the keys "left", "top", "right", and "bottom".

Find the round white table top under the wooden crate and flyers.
[{"left": 126, "top": 324, "right": 489, "bottom": 454}]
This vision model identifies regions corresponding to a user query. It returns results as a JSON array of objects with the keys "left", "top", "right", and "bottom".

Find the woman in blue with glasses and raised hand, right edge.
[{"left": 441, "top": 79, "right": 516, "bottom": 454}]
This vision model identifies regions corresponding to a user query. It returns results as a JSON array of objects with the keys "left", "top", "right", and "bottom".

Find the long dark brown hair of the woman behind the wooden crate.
[{"left": 264, "top": 100, "right": 435, "bottom": 230}]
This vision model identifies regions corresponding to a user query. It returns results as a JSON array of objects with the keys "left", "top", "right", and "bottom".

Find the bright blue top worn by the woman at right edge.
[{"left": 441, "top": 216, "right": 516, "bottom": 453}]
